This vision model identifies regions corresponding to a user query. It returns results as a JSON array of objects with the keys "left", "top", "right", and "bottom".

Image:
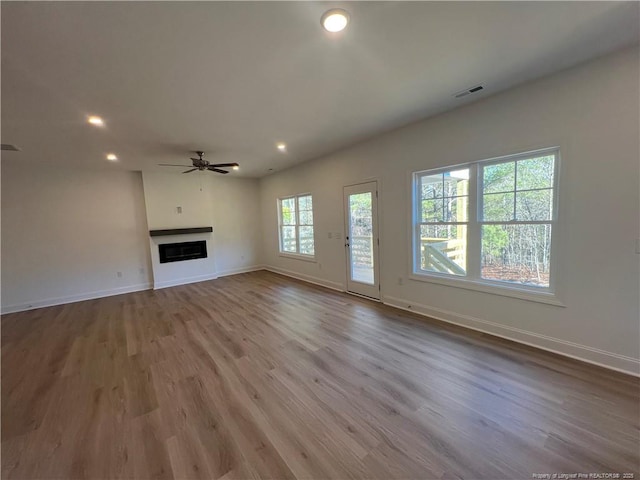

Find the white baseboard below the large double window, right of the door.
[{"left": 383, "top": 296, "right": 640, "bottom": 377}]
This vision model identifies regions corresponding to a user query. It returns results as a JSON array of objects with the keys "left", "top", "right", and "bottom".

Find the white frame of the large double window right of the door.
[{"left": 409, "top": 146, "right": 565, "bottom": 306}]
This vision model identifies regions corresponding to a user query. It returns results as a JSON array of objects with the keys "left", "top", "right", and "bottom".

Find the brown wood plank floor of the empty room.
[{"left": 2, "top": 272, "right": 640, "bottom": 480}]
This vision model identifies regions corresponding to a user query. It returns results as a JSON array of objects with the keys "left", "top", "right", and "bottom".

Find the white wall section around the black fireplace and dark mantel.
[{"left": 143, "top": 172, "right": 261, "bottom": 282}]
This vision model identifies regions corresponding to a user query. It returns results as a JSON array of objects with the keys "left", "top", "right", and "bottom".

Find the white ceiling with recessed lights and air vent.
[{"left": 1, "top": 2, "right": 639, "bottom": 176}]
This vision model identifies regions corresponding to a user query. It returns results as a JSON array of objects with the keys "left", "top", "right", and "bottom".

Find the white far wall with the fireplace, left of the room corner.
[{"left": 1, "top": 168, "right": 261, "bottom": 313}]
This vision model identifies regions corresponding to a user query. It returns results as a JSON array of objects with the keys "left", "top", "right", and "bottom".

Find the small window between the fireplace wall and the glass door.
[{"left": 278, "top": 195, "right": 315, "bottom": 257}]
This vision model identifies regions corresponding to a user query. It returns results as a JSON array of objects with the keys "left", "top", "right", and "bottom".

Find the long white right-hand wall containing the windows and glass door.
[{"left": 261, "top": 49, "right": 640, "bottom": 374}]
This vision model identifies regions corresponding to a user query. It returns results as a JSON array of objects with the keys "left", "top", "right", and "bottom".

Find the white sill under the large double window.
[{"left": 409, "top": 273, "right": 566, "bottom": 307}]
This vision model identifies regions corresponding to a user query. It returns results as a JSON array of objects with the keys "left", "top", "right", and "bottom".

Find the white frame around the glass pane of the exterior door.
[{"left": 342, "top": 178, "right": 382, "bottom": 302}]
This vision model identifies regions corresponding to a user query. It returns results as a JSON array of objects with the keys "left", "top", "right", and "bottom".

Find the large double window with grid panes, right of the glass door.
[{"left": 413, "top": 149, "right": 559, "bottom": 300}]
